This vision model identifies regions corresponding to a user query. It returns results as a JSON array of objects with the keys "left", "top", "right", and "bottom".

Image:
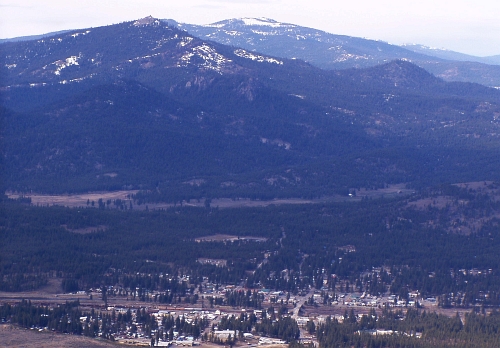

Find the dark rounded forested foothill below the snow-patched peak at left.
[{"left": 1, "top": 82, "right": 296, "bottom": 191}]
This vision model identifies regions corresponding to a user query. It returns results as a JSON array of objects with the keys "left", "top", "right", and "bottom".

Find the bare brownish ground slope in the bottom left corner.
[{"left": 0, "top": 324, "right": 117, "bottom": 348}]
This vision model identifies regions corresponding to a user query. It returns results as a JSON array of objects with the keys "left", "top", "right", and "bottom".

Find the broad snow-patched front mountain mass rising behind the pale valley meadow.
[{"left": 0, "top": 17, "right": 500, "bottom": 201}]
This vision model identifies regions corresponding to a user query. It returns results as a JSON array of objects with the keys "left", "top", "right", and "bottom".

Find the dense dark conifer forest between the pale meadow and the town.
[{"left": 0, "top": 183, "right": 500, "bottom": 308}]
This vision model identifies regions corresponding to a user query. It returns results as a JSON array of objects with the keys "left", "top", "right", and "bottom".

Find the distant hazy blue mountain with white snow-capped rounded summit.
[{"left": 170, "top": 18, "right": 429, "bottom": 69}]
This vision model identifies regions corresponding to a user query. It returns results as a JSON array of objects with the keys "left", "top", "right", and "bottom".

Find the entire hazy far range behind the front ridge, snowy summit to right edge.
[{"left": 172, "top": 18, "right": 500, "bottom": 86}]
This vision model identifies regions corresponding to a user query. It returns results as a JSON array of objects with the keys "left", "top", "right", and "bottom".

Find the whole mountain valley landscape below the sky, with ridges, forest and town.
[{"left": 0, "top": 17, "right": 500, "bottom": 348}]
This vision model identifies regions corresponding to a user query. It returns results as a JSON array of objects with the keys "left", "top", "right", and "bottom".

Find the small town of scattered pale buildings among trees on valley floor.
[{"left": 0, "top": 276, "right": 454, "bottom": 347}]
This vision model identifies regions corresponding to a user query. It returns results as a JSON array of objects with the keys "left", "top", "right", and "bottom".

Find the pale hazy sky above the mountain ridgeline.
[{"left": 0, "top": 0, "right": 500, "bottom": 56}]
